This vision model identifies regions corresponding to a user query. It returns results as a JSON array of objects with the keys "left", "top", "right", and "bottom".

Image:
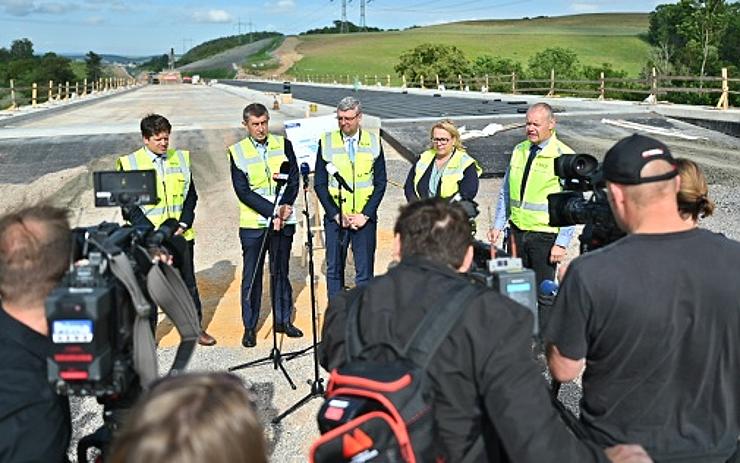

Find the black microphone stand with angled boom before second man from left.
[{"left": 229, "top": 185, "right": 297, "bottom": 390}]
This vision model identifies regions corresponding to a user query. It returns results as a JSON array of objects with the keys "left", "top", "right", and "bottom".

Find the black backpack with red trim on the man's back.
[{"left": 310, "top": 284, "right": 483, "bottom": 463}]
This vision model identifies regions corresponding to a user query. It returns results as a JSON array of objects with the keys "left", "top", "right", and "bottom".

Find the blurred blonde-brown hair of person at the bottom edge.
[{"left": 106, "top": 373, "right": 267, "bottom": 463}]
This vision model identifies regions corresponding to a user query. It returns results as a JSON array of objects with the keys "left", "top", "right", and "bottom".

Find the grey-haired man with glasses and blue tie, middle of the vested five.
[{"left": 314, "top": 96, "right": 387, "bottom": 298}]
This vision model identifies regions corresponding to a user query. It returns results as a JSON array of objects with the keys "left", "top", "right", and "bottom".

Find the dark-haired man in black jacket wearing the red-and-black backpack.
[{"left": 320, "top": 198, "right": 649, "bottom": 462}]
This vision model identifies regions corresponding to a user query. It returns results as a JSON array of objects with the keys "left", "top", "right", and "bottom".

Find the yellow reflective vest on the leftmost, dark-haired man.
[{"left": 116, "top": 148, "right": 195, "bottom": 241}]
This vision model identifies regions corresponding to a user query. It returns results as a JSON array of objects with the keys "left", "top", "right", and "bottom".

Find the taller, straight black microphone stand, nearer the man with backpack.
[{"left": 272, "top": 169, "right": 324, "bottom": 424}]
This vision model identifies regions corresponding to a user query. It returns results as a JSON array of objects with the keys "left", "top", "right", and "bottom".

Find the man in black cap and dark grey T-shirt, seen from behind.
[{"left": 544, "top": 135, "right": 740, "bottom": 462}]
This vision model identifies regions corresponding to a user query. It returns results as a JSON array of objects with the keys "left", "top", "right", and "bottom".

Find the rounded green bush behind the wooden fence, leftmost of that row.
[{"left": 394, "top": 43, "right": 470, "bottom": 87}]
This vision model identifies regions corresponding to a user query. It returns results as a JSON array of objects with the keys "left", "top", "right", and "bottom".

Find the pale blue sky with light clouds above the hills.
[{"left": 0, "top": 0, "right": 674, "bottom": 56}]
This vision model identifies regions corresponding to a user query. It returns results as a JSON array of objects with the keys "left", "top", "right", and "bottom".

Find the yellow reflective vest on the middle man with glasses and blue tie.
[{"left": 321, "top": 130, "right": 380, "bottom": 214}]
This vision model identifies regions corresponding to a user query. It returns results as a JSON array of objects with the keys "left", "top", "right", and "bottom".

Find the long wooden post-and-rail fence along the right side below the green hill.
[{"left": 272, "top": 68, "right": 740, "bottom": 110}]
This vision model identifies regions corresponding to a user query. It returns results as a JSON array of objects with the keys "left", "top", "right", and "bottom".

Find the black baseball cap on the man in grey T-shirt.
[{"left": 604, "top": 134, "right": 678, "bottom": 185}]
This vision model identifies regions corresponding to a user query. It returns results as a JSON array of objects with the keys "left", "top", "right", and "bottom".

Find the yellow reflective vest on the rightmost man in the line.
[{"left": 509, "top": 134, "right": 573, "bottom": 233}]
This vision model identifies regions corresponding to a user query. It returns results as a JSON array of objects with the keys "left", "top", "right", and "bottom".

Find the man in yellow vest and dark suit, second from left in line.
[{"left": 228, "top": 103, "right": 303, "bottom": 347}]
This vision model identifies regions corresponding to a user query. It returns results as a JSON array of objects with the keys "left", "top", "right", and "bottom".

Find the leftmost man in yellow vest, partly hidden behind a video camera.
[{"left": 116, "top": 114, "right": 216, "bottom": 346}]
